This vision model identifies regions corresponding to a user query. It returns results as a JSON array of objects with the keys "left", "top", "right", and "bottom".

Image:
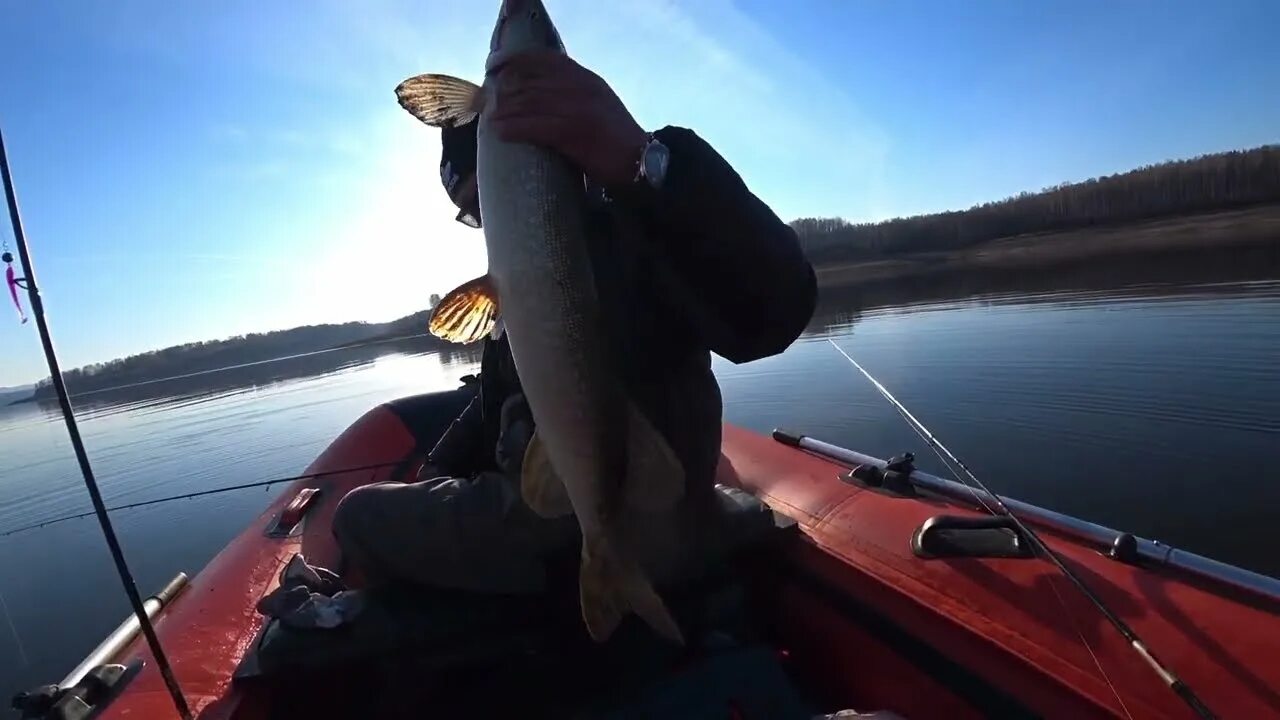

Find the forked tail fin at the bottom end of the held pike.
[{"left": 579, "top": 537, "right": 685, "bottom": 644}]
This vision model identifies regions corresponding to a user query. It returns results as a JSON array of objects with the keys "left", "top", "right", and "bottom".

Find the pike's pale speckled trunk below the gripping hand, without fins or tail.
[{"left": 476, "top": 3, "right": 616, "bottom": 548}]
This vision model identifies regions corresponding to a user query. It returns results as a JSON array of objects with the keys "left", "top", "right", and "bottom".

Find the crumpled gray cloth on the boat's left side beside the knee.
[{"left": 257, "top": 553, "right": 365, "bottom": 629}]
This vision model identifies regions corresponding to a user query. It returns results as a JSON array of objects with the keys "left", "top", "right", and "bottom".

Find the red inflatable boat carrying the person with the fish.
[{"left": 24, "top": 389, "right": 1280, "bottom": 720}]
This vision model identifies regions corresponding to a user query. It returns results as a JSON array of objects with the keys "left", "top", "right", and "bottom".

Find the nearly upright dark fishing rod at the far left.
[{"left": 0, "top": 132, "right": 192, "bottom": 720}]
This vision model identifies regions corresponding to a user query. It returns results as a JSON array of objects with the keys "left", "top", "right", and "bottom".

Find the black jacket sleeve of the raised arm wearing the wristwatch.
[{"left": 611, "top": 127, "right": 817, "bottom": 363}]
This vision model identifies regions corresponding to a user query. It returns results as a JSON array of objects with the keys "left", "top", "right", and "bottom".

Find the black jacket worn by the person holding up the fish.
[{"left": 431, "top": 127, "right": 817, "bottom": 489}]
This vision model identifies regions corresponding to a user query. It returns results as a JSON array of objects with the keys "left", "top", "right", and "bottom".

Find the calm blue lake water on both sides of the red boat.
[{"left": 0, "top": 260, "right": 1280, "bottom": 697}]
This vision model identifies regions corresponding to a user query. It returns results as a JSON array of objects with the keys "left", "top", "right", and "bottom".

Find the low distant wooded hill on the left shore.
[{"left": 27, "top": 310, "right": 445, "bottom": 398}]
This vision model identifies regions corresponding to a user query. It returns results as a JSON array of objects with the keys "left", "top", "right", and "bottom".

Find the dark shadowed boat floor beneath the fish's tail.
[{"left": 241, "top": 540, "right": 840, "bottom": 720}]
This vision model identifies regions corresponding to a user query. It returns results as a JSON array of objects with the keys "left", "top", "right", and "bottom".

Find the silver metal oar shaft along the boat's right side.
[{"left": 773, "top": 430, "right": 1280, "bottom": 602}]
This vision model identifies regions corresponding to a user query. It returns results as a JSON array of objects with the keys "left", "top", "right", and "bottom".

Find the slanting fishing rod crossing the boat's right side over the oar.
[{"left": 827, "top": 338, "right": 1217, "bottom": 719}]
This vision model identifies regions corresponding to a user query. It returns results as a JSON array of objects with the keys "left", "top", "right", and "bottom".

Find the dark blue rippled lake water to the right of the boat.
[{"left": 717, "top": 252, "right": 1280, "bottom": 577}]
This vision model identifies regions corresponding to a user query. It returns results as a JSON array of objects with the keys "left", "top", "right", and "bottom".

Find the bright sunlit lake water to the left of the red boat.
[{"left": 0, "top": 340, "right": 479, "bottom": 697}]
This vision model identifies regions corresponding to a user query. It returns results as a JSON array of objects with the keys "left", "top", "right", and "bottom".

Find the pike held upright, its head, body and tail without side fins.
[{"left": 476, "top": 0, "right": 678, "bottom": 639}]
